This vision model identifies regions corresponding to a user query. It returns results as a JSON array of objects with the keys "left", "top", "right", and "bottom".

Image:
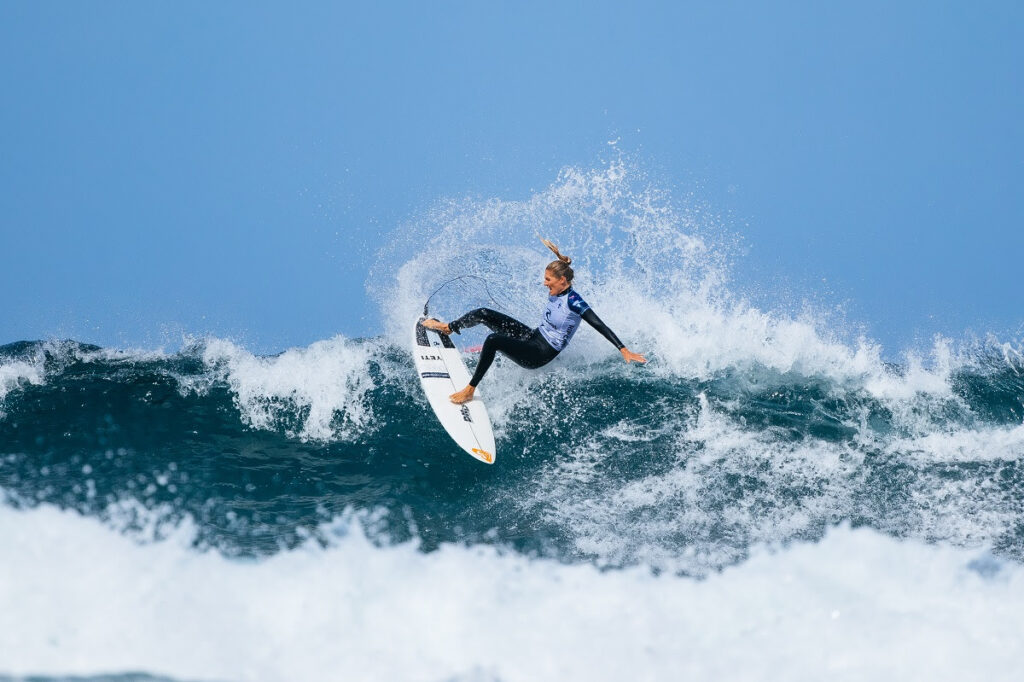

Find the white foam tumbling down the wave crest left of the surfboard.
[{"left": 195, "top": 336, "right": 380, "bottom": 441}]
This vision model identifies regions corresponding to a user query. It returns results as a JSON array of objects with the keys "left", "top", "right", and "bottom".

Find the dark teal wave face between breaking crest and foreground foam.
[{"left": 0, "top": 327, "right": 1024, "bottom": 576}]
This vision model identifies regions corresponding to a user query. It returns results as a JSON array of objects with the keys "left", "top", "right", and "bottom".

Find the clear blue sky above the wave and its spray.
[{"left": 0, "top": 2, "right": 1024, "bottom": 351}]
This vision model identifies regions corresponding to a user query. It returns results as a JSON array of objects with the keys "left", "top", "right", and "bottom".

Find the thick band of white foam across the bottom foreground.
[{"left": 0, "top": 507, "right": 1024, "bottom": 682}]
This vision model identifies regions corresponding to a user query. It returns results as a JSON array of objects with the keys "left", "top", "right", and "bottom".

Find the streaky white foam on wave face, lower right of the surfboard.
[{"left": 524, "top": 387, "right": 1024, "bottom": 574}]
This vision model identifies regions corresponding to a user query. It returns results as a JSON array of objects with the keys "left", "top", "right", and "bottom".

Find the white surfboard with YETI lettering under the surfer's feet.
[{"left": 413, "top": 317, "right": 495, "bottom": 464}]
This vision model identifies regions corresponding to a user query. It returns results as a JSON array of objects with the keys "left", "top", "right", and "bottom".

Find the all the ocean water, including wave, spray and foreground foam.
[{"left": 0, "top": 161, "right": 1024, "bottom": 681}]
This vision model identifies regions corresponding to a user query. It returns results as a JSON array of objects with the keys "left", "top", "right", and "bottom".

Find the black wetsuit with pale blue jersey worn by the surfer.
[{"left": 449, "top": 289, "right": 624, "bottom": 387}]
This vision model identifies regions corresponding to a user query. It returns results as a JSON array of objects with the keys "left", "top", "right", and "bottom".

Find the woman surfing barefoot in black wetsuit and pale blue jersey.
[{"left": 423, "top": 240, "right": 647, "bottom": 403}]
